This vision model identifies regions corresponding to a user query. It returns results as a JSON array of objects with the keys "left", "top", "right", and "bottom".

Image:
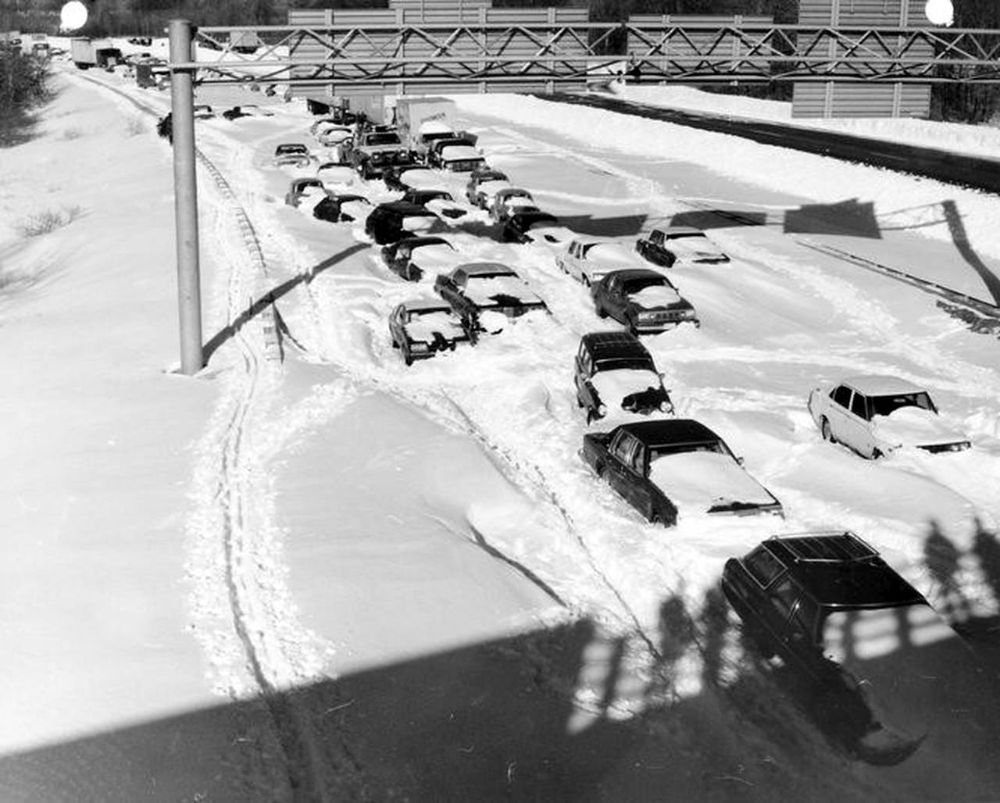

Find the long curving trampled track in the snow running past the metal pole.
[{"left": 70, "top": 70, "right": 360, "bottom": 801}]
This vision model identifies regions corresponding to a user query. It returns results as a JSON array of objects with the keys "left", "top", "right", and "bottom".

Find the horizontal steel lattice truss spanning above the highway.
[{"left": 176, "top": 23, "right": 1000, "bottom": 88}]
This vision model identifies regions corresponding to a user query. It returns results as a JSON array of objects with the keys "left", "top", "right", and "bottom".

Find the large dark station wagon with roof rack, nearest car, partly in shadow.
[{"left": 722, "top": 531, "right": 976, "bottom": 764}]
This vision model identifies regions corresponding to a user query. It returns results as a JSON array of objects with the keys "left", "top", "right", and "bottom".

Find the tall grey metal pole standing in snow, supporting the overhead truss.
[{"left": 169, "top": 15, "right": 205, "bottom": 375}]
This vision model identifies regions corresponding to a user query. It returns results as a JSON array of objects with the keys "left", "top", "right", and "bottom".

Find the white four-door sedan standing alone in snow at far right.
[{"left": 808, "top": 374, "right": 971, "bottom": 459}]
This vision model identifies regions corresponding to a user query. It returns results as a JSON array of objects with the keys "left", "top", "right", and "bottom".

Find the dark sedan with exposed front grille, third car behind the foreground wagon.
[{"left": 590, "top": 268, "right": 701, "bottom": 334}]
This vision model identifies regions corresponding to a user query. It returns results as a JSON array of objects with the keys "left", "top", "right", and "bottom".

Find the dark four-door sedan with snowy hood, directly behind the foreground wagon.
[{"left": 582, "top": 418, "right": 783, "bottom": 527}]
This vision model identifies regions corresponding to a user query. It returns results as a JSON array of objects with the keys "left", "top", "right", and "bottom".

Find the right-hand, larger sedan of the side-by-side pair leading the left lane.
[{"left": 434, "top": 262, "right": 548, "bottom": 335}]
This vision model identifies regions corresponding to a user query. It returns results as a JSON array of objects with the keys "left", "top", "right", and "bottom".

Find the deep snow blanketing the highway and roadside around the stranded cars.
[{"left": 0, "top": 55, "right": 1000, "bottom": 800}]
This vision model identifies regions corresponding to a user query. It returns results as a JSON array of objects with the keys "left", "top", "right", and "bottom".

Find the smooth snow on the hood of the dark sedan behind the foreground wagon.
[{"left": 649, "top": 452, "right": 775, "bottom": 514}]
